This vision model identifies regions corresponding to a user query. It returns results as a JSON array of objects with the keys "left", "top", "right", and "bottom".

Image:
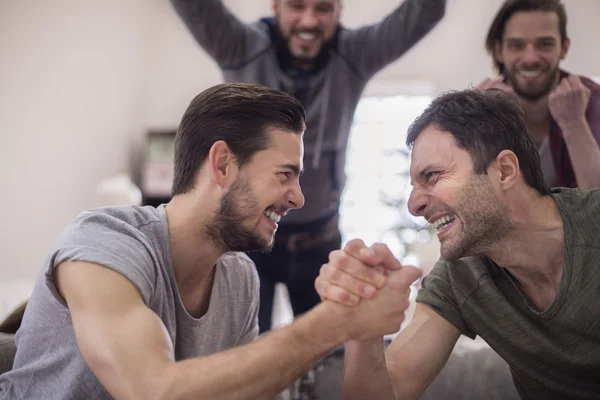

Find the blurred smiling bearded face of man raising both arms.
[{"left": 273, "top": 0, "right": 341, "bottom": 63}]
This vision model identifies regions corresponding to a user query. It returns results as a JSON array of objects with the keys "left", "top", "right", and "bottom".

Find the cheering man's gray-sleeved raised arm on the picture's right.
[{"left": 339, "top": 0, "right": 446, "bottom": 79}]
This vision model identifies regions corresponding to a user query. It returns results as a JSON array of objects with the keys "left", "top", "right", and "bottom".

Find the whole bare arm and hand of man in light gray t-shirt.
[{"left": 55, "top": 262, "right": 406, "bottom": 400}]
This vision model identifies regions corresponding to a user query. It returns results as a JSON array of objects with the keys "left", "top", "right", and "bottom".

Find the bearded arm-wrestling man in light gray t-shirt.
[{"left": 0, "top": 84, "right": 420, "bottom": 400}]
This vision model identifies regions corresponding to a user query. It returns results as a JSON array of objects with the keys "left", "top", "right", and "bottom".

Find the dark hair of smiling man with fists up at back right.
[{"left": 485, "top": 0, "right": 567, "bottom": 73}]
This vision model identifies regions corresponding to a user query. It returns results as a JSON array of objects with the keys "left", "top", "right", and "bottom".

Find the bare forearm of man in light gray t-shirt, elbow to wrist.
[{"left": 166, "top": 302, "right": 346, "bottom": 400}]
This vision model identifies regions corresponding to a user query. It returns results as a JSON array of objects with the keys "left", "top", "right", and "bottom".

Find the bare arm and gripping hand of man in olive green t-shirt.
[{"left": 315, "top": 240, "right": 460, "bottom": 400}]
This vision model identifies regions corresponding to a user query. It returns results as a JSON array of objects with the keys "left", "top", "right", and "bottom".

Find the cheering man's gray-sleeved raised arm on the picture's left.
[{"left": 171, "top": 0, "right": 270, "bottom": 68}]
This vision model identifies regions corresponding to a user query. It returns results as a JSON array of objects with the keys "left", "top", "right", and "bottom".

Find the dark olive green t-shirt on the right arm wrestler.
[{"left": 417, "top": 189, "right": 600, "bottom": 399}]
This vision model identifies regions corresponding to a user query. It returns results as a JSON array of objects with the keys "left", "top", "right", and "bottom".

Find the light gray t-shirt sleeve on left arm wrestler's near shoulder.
[{"left": 45, "top": 211, "right": 156, "bottom": 305}]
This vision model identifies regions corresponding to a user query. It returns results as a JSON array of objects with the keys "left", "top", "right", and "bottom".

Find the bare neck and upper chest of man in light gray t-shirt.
[{"left": 166, "top": 194, "right": 224, "bottom": 315}]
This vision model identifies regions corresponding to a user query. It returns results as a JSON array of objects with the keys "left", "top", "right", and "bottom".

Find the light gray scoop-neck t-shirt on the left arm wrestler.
[{"left": 0, "top": 206, "right": 259, "bottom": 400}]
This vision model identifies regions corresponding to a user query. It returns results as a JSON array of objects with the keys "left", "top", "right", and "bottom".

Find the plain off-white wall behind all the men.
[{"left": 0, "top": 0, "right": 600, "bottom": 281}]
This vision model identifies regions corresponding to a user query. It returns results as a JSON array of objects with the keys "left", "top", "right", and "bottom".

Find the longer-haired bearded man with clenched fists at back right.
[{"left": 478, "top": 0, "right": 600, "bottom": 189}]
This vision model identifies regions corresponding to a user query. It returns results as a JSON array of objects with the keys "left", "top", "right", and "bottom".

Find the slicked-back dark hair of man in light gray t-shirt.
[{"left": 172, "top": 83, "right": 306, "bottom": 196}]
